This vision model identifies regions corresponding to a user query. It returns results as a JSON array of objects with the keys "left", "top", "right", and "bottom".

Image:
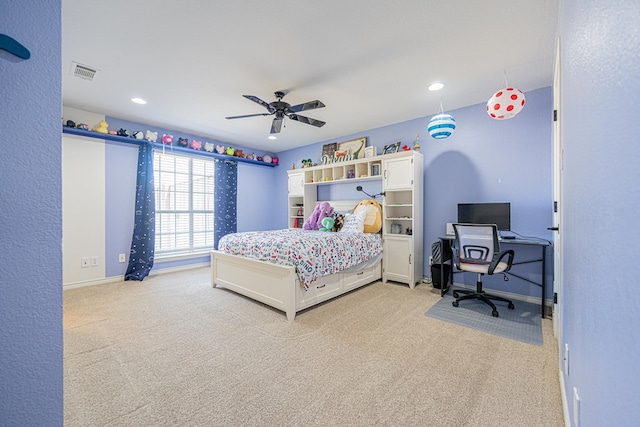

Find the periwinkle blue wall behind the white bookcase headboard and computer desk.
[{"left": 274, "top": 87, "right": 553, "bottom": 299}]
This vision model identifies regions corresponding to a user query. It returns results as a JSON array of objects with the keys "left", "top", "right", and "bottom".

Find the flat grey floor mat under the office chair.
[{"left": 425, "top": 295, "right": 542, "bottom": 345}]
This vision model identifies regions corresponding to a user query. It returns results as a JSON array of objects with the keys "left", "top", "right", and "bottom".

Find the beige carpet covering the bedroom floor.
[{"left": 64, "top": 268, "right": 563, "bottom": 427}]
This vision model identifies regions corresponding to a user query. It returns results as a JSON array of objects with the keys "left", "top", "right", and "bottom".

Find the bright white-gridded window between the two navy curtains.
[{"left": 153, "top": 152, "right": 214, "bottom": 256}]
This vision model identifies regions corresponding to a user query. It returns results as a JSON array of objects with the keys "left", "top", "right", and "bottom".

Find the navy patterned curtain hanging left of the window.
[{"left": 124, "top": 141, "right": 156, "bottom": 280}]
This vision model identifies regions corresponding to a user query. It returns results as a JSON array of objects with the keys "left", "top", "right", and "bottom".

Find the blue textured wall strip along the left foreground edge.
[{"left": 0, "top": 0, "right": 64, "bottom": 426}]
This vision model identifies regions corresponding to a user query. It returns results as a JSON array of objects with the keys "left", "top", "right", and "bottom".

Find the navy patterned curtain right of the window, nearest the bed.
[{"left": 213, "top": 159, "right": 238, "bottom": 249}]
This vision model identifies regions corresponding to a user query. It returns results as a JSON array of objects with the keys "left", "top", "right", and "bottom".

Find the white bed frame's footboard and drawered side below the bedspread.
[{"left": 211, "top": 251, "right": 382, "bottom": 321}]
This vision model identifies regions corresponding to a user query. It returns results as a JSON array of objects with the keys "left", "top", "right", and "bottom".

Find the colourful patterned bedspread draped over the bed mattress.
[{"left": 218, "top": 229, "right": 382, "bottom": 290}]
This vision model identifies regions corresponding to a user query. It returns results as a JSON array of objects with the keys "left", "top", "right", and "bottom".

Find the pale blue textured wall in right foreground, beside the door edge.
[{"left": 558, "top": 0, "right": 640, "bottom": 427}]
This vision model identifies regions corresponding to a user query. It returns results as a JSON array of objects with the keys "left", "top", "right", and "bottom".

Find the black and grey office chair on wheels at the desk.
[{"left": 452, "top": 224, "right": 514, "bottom": 317}]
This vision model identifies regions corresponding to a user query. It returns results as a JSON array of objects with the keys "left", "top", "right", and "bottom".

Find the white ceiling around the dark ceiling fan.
[{"left": 62, "top": 0, "right": 559, "bottom": 152}]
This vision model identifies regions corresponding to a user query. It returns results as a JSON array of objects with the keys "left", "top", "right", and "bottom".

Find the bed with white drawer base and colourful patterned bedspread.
[{"left": 211, "top": 209, "right": 382, "bottom": 321}]
